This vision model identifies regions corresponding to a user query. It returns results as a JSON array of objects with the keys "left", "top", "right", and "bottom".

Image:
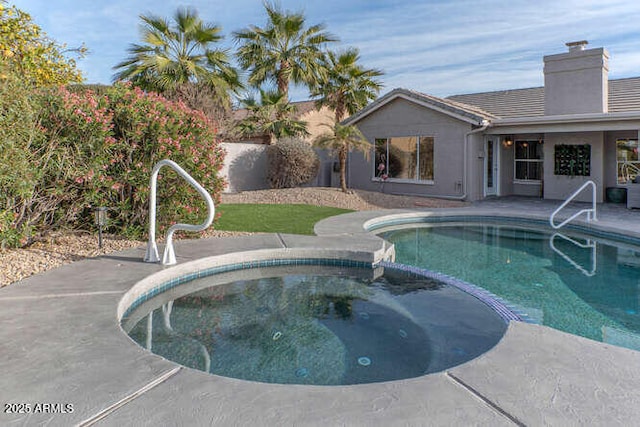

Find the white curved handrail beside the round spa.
[{"left": 144, "top": 159, "right": 215, "bottom": 265}]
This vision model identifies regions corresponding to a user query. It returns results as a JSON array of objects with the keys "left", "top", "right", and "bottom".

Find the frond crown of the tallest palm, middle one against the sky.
[{"left": 233, "top": 2, "right": 337, "bottom": 102}]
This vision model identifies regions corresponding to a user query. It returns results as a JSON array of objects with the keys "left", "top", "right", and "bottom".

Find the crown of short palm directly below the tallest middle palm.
[{"left": 236, "top": 89, "right": 309, "bottom": 143}]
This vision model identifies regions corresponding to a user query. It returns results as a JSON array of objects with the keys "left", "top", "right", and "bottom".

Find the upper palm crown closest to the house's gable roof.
[{"left": 311, "top": 48, "right": 383, "bottom": 123}]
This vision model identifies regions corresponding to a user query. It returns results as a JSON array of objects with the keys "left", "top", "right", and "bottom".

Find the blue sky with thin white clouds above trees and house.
[{"left": 9, "top": 0, "right": 640, "bottom": 100}]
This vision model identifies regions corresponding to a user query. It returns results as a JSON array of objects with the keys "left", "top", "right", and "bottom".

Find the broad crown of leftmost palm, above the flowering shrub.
[{"left": 113, "top": 8, "right": 241, "bottom": 98}]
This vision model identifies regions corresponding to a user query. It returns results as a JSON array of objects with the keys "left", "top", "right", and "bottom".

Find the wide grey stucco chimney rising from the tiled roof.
[{"left": 544, "top": 40, "right": 609, "bottom": 116}]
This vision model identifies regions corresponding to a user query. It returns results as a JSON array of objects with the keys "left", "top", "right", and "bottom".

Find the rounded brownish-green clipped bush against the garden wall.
[{"left": 267, "top": 138, "right": 320, "bottom": 188}]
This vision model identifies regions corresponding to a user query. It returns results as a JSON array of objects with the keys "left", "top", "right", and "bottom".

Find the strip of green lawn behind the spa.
[{"left": 214, "top": 203, "right": 353, "bottom": 235}]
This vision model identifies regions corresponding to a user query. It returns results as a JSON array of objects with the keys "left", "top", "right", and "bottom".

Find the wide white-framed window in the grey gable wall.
[{"left": 373, "top": 136, "right": 434, "bottom": 181}]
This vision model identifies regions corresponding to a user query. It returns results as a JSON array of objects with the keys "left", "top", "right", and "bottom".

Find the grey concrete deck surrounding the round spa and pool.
[{"left": 0, "top": 199, "right": 640, "bottom": 426}]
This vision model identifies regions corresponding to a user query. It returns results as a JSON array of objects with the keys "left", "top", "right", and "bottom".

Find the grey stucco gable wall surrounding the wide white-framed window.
[{"left": 349, "top": 99, "right": 472, "bottom": 198}]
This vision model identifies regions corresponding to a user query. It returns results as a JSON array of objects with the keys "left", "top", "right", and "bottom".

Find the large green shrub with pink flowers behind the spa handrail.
[{"left": 0, "top": 80, "right": 224, "bottom": 246}]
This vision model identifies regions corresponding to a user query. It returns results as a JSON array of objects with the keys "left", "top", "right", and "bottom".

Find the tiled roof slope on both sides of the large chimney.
[{"left": 445, "top": 77, "right": 640, "bottom": 118}]
